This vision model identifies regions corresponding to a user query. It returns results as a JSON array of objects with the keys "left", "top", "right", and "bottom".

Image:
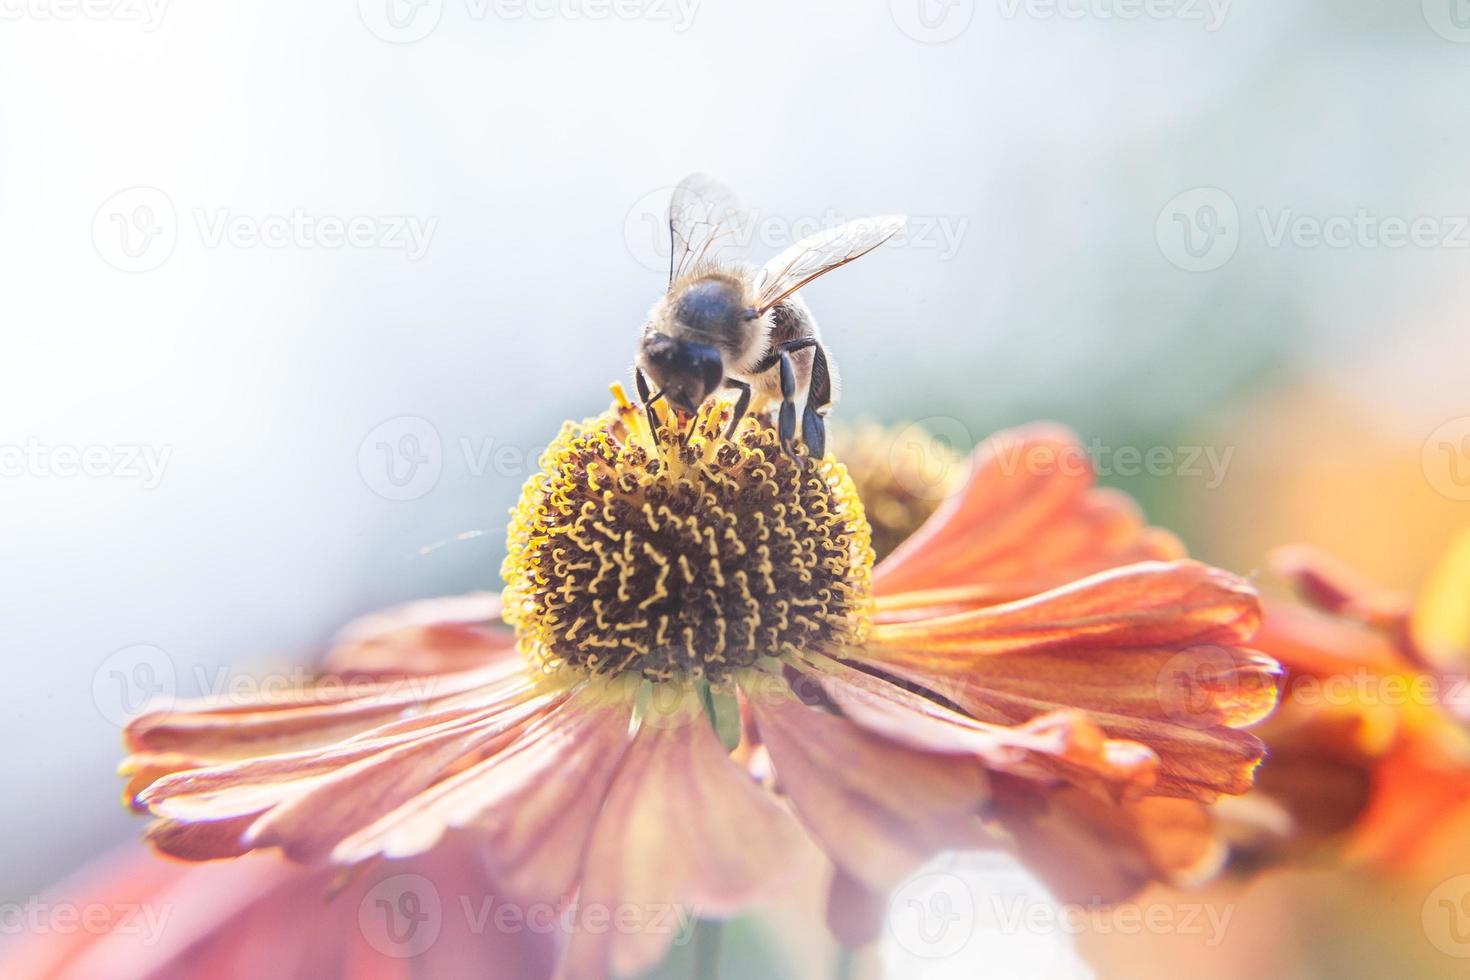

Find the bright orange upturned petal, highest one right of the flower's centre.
[{"left": 873, "top": 423, "right": 1183, "bottom": 598}]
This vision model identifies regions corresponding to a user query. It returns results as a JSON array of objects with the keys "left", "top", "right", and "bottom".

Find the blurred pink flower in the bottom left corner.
[{"left": 0, "top": 839, "right": 556, "bottom": 980}]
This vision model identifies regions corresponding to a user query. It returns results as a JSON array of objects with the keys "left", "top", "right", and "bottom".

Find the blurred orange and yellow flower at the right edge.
[{"left": 1248, "top": 532, "right": 1470, "bottom": 867}]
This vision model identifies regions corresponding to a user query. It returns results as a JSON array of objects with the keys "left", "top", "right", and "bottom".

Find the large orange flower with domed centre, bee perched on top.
[{"left": 125, "top": 392, "right": 1276, "bottom": 977}]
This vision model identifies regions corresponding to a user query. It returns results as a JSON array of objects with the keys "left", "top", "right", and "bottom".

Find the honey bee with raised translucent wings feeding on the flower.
[{"left": 634, "top": 173, "right": 907, "bottom": 460}]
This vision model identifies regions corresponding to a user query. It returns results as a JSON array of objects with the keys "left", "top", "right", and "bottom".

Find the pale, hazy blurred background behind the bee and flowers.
[{"left": 0, "top": 0, "right": 1470, "bottom": 976}]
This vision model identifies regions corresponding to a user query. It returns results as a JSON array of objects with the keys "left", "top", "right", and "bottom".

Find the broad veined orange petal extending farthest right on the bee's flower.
[{"left": 863, "top": 561, "right": 1280, "bottom": 801}]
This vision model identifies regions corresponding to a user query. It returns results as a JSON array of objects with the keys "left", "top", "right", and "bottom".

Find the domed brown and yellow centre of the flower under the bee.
[{"left": 503, "top": 392, "right": 873, "bottom": 685}]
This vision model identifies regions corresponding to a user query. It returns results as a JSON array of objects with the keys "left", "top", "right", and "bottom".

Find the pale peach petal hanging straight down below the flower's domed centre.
[{"left": 566, "top": 699, "right": 803, "bottom": 977}]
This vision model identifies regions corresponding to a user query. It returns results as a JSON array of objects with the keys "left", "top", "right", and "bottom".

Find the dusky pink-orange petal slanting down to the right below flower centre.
[{"left": 751, "top": 693, "right": 986, "bottom": 889}]
